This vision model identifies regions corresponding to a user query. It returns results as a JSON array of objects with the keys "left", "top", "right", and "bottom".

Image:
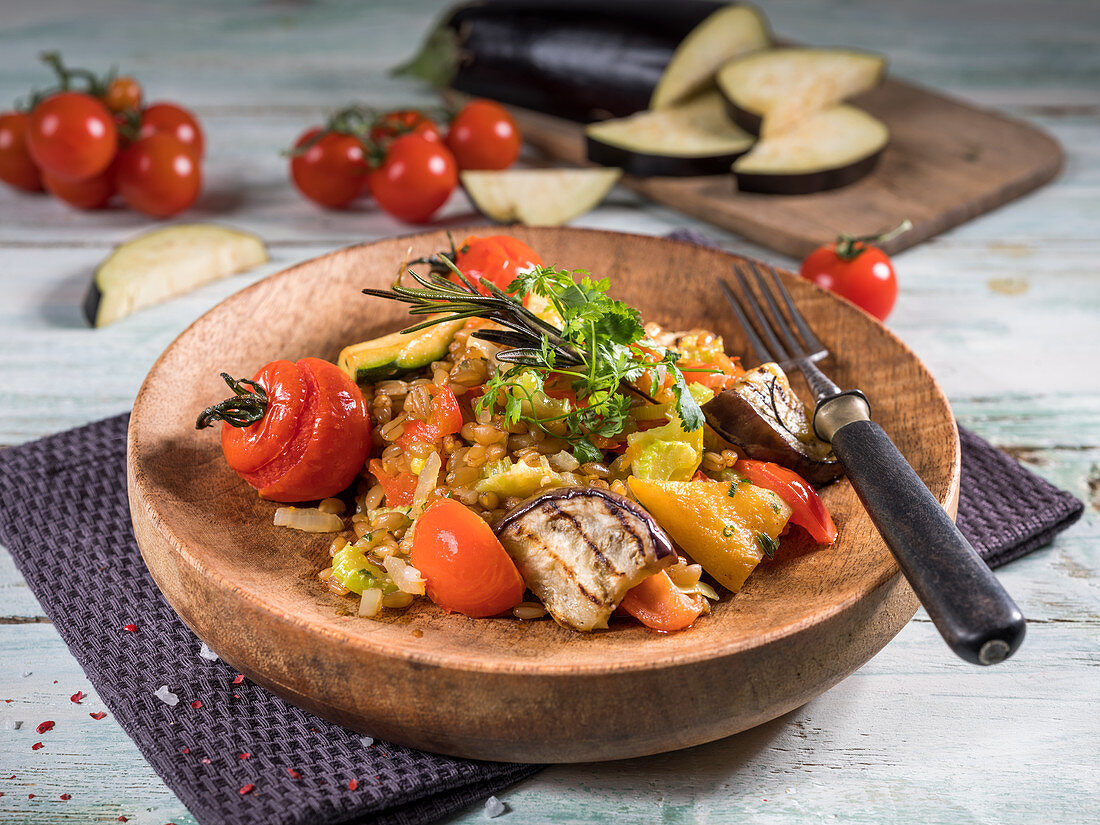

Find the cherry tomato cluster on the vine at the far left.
[{"left": 0, "top": 54, "right": 204, "bottom": 218}]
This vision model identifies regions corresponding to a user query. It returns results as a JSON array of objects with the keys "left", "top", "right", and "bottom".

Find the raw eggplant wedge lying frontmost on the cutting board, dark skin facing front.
[{"left": 733, "top": 106, "right": 890, "bottom": 195}]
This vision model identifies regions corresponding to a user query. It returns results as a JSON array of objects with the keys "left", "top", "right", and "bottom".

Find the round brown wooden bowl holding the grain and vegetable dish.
[{"left": 128, "top": 228, "right": 959, "bottom": 762}]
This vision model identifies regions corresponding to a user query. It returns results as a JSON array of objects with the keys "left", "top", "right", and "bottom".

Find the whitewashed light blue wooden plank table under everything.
[{"left": 0, "top": 0, "right": 1100, "bottom": 825}]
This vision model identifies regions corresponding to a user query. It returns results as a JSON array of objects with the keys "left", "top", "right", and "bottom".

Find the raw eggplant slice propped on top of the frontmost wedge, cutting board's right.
[{"left": 717, "top": 48, "right": 887, "bottom": 138}]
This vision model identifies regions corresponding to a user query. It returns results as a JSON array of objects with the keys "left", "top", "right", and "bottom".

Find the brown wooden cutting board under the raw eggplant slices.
[{"left": 503, "top": 79, "right": 1063, "bottom": 257}]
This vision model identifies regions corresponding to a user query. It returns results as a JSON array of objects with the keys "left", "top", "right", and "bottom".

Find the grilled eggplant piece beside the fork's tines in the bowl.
[{"left": 703, "top": 363, "right": 843, "bottom": 484}]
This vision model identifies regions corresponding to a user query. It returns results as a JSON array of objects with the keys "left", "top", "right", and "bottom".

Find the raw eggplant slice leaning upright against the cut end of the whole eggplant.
[{"left": 649, "top": 4, "right": 771, "bottom": 109}]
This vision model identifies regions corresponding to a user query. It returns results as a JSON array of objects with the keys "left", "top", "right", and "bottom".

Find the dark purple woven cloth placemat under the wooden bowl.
[{"left": 0, "top": 416, "right": 1084, "bottom": 825}]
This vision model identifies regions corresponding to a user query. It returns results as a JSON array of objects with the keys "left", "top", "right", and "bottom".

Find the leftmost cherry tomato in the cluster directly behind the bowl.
[{"left": 290, "top": 128, "right": 369, "bottom": 209}]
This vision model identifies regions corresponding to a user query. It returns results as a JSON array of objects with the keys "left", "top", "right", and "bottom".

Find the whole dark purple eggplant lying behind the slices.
[{"left": 397, "top": 0, "right": 726, "bottom": 122}]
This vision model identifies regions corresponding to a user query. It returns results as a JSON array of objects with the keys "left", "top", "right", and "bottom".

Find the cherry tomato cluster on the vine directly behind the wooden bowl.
[{"left": 290, "top": 100, "right": 521, "bottom": 223}]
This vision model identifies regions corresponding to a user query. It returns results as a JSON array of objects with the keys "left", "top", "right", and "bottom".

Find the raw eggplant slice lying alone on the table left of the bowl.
[{"left": 84, "top": 223, "right": 267, "bottom": 327}]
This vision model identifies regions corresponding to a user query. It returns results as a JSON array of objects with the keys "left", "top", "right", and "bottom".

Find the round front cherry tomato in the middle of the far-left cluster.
[{"left": 26, "top": 91, "right": 119, "bottom": 180}]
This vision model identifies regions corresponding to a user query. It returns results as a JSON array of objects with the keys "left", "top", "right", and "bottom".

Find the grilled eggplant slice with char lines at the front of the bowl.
[{"left": 496, "top": 487, "right": 677, "bottom": 630}]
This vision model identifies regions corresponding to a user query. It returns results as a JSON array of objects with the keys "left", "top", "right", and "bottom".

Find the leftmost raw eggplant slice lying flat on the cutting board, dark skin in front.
[{"left": 584, "top": 91, "right": 754, "bottom": 177}]
